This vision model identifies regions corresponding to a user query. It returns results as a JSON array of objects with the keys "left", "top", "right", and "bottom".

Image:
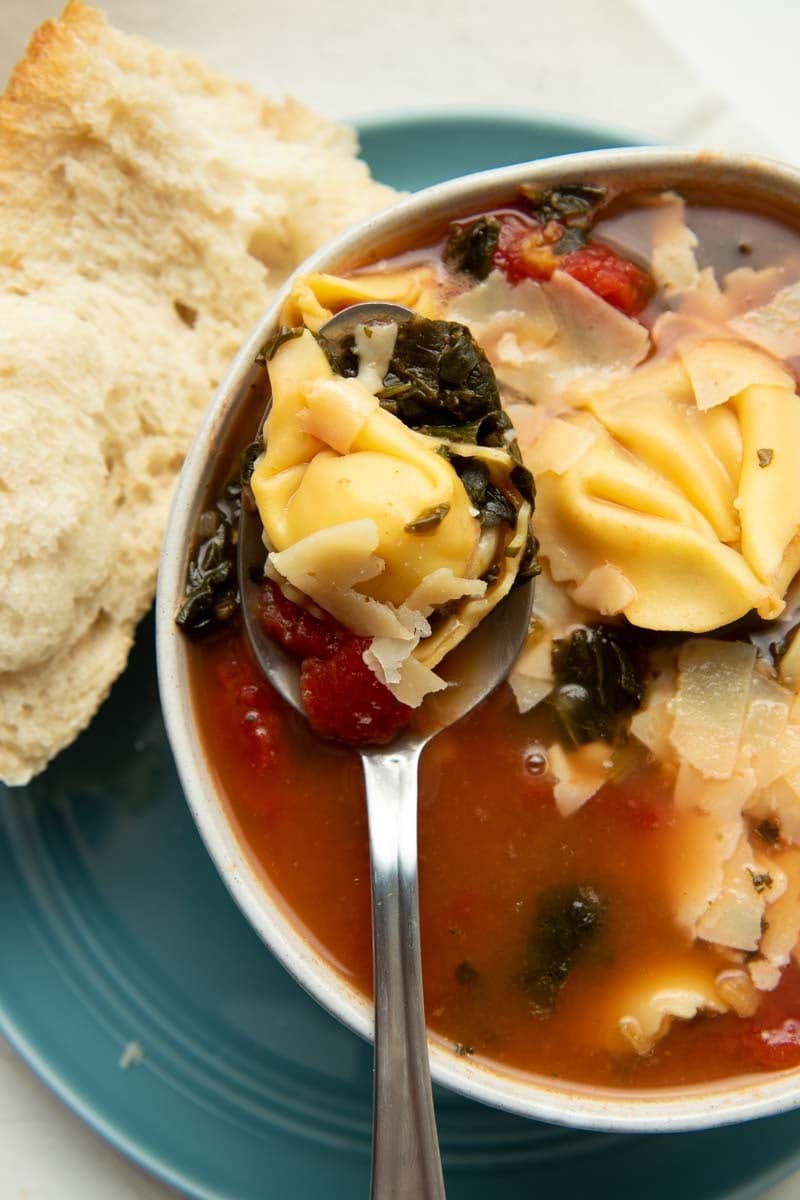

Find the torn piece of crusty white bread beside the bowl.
[{"left": 0, "top": 2, "right": 393, "bottom": 784}]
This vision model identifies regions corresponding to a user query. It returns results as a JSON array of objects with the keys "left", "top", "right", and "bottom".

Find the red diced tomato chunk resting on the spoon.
[{"left": 300, "top": 635, "right": 411, "bottom": 745}]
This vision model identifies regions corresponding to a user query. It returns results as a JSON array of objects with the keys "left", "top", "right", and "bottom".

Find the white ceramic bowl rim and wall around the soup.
[{"left": 157, "top": 149, "right": 800, "bottom": 1132}]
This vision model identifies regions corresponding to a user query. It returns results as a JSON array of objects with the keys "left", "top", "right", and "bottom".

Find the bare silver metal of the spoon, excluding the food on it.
[{"left": 239, "top": 304, "right": 533, "bottom": 1200}]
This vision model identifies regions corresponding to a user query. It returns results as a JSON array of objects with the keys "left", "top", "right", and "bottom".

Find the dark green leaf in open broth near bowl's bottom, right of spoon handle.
[{"left": 519, "top": 884, "right": 607, "bottom": 1016}]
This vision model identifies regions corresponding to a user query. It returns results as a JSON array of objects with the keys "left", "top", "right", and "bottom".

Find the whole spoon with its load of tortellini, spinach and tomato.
[{"left": 239, "top": 297, "right": 535, "bottom": 1200}]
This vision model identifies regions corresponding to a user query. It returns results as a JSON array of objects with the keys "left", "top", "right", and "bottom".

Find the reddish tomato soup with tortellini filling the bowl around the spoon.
[{"left": 183, "top": 188, "right": 800, "bottom": 1086}]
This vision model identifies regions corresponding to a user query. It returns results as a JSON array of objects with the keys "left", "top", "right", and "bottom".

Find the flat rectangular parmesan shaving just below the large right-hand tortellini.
[{"left": 669, "top": 638, "right": 756, "bottom": 779}]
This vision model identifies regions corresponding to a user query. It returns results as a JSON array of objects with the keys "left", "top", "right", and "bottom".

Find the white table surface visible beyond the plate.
[{"left": 0, "top": 0, "right": 800, "bottom": 1200}]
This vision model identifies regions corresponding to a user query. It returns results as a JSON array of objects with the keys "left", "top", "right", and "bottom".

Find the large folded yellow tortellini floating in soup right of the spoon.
[{"left": 529, "top": 341, "right": 800, "bottom": 632}]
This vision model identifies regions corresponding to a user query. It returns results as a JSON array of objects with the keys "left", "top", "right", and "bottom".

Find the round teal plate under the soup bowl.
[{"left": 0, "top": 113, "right": 800, "bottom": 1200}]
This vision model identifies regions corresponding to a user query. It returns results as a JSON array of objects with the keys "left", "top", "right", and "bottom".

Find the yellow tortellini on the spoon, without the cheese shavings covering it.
[{"left": 252, "top": 332, "right": 488, "bottom": 605}]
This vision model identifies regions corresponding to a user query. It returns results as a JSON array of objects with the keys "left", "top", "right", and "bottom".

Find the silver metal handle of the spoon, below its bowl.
[{"left": 362, "top": 744, "right": 445, "bottom": 1200}]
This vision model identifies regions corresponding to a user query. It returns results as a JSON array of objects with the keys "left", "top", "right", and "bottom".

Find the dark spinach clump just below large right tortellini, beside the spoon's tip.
[{"left": 551, "top": 625, "right": 644, "bottom": 745}]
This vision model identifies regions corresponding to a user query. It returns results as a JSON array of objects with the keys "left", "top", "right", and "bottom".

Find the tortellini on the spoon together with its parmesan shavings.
[{"left": 251, "top": 325, "right": 530, "bottom": 704}]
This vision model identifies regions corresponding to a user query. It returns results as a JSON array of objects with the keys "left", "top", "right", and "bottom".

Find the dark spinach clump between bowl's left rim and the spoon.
[{"left": 175, "top": 442, "right": 264, "bottom": 636}]
